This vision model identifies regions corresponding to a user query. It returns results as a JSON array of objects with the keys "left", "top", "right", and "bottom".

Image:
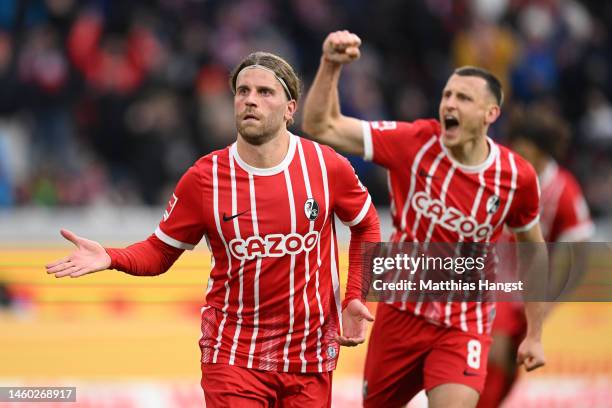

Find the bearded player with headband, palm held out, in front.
[{"left": 47, "top": 52, "right": 380, "bottom": 407}]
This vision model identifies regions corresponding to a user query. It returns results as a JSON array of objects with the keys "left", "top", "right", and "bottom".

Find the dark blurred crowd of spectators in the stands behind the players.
[{"left": 0, "top": 0, "right": 612, "bottom": 218}]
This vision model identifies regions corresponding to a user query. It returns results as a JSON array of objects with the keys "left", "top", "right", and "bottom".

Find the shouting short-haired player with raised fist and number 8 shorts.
[{"left": 303, "top": 31, "right": 545, "bottom": 408}]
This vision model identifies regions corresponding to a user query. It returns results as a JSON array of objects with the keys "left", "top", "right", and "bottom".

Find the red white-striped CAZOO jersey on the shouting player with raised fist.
[{"left": 362, "top": 119, "right": 540, "bottom": 334}]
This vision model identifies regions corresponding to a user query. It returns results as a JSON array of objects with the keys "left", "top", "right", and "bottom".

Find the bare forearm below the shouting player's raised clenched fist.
[{"left": 303, "top": 57, "right": 342, "bottom": 137}]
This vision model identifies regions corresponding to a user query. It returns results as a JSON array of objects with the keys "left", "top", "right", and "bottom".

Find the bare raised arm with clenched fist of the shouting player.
[{"left": 303, "top": 31, "right": 364, "bottom": 156}]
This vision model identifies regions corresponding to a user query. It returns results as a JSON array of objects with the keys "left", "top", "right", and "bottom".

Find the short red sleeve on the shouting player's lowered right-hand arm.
[{"left": 506, "top": 155, "right": 540, "bottom": 233}]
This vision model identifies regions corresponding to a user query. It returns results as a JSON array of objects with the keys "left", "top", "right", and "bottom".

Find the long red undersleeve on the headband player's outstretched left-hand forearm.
[{"left": 105, "top": 235, "right": 183, "bottom": 276}]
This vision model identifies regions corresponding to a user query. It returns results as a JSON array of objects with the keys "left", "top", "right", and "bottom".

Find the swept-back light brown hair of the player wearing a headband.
[{"left": 230, "top": 51, "right": 302, "bottom": 101}]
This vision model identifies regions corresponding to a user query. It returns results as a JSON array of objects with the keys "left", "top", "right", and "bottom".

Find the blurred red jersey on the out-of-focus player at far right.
[{"left": 540, "top": 161, "right": 595, "bottom": 242}]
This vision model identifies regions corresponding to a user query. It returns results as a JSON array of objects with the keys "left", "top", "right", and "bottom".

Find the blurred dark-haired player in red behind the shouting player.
[{"left": 478, "top": 107, "right": 594, "bottom": 408}]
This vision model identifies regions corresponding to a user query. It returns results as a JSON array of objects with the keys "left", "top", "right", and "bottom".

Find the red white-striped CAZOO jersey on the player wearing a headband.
[{"left": 155, "top": 135, "right": 371, "bottom": 372}]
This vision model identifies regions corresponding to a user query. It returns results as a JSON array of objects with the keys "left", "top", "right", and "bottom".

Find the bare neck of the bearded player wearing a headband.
[{"left": 236, "top": 129, "right": 289, "bottom": 169}]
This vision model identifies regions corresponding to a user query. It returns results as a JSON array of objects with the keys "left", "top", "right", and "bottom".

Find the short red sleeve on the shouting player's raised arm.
[{"left": 362, "top": 119, "right": 440, "bottom": 169}]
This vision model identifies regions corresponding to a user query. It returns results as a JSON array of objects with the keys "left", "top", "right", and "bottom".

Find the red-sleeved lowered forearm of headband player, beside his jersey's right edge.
[{"left": 342, "top": 205, "right": 380, "bottom": 309}]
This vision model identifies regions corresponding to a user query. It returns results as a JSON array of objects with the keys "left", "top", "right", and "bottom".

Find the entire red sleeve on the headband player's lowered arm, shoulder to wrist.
[{"left": 332, "top": 153, "right": 380, "bottom": 309}]
